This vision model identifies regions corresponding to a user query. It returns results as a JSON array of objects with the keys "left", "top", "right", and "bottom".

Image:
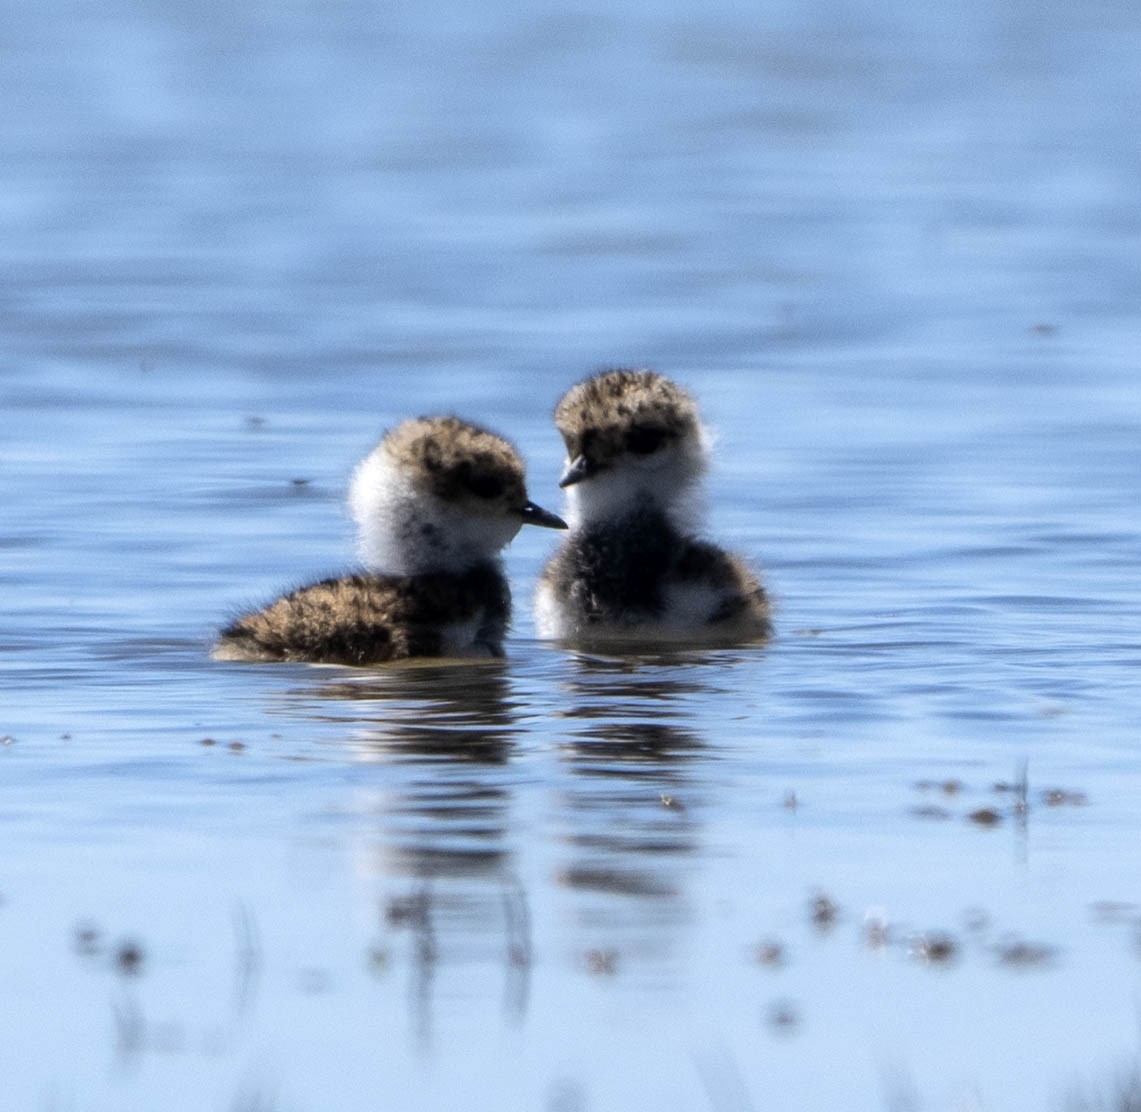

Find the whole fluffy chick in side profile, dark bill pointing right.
[{"left": 213, "top": 417, "right": 566, "bottom": 665}]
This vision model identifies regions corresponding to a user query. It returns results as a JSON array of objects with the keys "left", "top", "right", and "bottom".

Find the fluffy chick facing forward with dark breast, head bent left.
[{"left": 535, "top": 370, "right": 771, "bottom": 644}]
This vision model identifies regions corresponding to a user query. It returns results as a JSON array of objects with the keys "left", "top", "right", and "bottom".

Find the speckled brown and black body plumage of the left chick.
[{"left": 215, "top": 563, "right": 511, "bottom": 665}]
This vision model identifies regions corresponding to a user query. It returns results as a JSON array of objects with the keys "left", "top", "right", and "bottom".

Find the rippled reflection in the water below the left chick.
[{"left": 289, "top": 661, "right": 532, "bottom": 1050}]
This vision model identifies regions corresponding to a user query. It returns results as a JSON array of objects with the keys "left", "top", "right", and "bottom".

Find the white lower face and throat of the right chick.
[{"left": 566, "top": 435, "right": 706, "bottom": 527}]
